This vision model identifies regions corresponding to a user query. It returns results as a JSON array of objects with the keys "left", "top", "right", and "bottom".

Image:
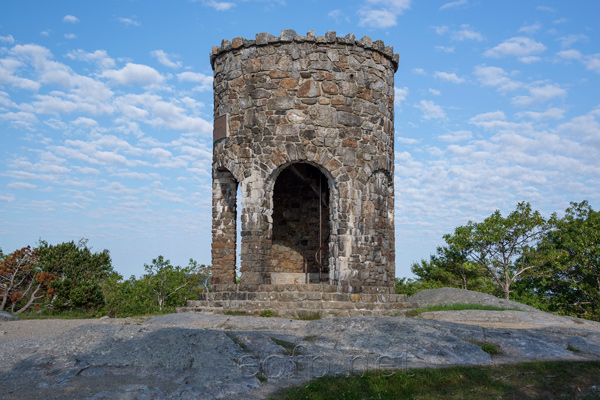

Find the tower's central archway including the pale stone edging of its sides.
[{"left": 263, "top": 161, "right": 339, "bottom": 284}]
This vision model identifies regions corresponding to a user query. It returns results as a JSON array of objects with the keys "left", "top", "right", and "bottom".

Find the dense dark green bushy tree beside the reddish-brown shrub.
[{"left": 37, "top": 239, "right": 112, "bottom": 311}]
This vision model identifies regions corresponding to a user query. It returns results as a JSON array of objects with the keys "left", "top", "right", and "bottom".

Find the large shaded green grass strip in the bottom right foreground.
[{"left": 269, "top": 361, "right": 600, "bottom": 400}]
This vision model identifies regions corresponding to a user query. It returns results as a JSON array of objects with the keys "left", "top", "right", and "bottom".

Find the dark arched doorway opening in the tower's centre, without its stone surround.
[{"left": 268, "top": 163, "right": 331, "bottom": 284}]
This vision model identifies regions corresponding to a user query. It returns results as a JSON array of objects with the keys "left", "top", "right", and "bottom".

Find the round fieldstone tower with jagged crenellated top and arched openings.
[{"left": 210, "top": 30, "right": 398, "bottom": 293}]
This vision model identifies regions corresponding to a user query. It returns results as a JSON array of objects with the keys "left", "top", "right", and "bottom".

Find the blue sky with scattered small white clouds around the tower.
[{"left": 0, "top": 0, "right": 600, "bottom": 276}]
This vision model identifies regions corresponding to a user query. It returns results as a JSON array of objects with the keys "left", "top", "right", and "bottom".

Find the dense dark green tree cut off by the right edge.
[{"left": 539, "top": 201, "right": 600, "bottom": 320}]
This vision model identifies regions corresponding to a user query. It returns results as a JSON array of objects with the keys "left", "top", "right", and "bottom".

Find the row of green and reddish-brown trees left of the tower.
[{"left": 0, "top": 239, "right": 209, "bottom": 317}]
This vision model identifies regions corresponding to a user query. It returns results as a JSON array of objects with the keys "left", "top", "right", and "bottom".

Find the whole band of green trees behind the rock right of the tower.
[{"left": 396, "top": 201, "right": 600, "bottom": 321}]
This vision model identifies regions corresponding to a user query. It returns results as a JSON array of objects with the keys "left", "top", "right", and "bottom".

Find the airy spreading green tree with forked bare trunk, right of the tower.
[{"left": 444, "top": 202, "right": 556, "bottom": 299}]
